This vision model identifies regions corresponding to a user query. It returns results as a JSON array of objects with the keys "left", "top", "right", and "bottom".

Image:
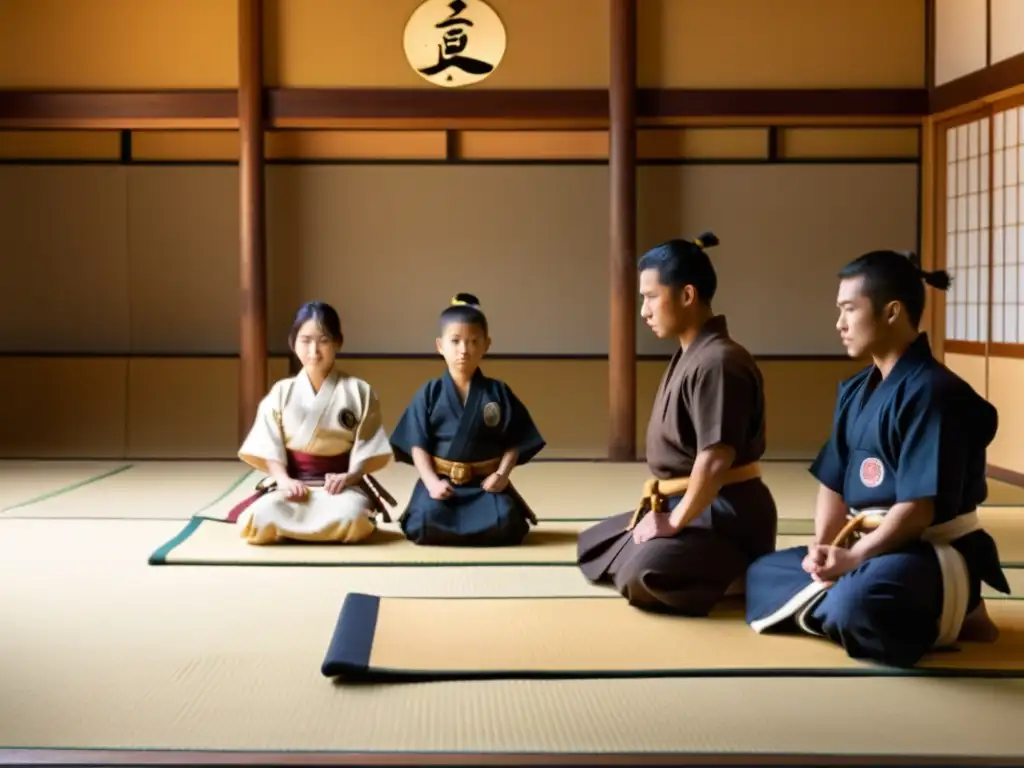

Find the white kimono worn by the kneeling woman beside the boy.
[{"left": 239, "top": 371, "right": 392, "bottom": 544}]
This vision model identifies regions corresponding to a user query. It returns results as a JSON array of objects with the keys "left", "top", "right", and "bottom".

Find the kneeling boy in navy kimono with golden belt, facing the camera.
[{"left": 391, "top": 294, "right": 544, "bottom": 547}]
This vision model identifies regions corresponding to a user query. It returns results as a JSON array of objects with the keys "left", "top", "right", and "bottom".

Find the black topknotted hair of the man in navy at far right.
[{"left": 839, "top": 251, "right": 951, "bottom": 329}]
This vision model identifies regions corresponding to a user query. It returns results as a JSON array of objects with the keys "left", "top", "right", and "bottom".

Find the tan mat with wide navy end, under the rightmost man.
[{"left": 321, "top": 593, "right": 1024, "bottom": 682}]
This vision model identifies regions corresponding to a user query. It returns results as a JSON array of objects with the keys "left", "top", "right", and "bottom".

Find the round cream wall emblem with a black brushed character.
[{"left": 402, "top": 0, "right": 506, "bottom": 88}]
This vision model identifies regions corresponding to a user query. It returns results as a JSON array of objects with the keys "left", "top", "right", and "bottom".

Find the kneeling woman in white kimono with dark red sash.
[{"left": 239, "top": 301, "right": 395, "bottom": 544}]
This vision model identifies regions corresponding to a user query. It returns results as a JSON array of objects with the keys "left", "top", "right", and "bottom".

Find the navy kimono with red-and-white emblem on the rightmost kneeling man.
[{"left": 746, "top": 334, "right": 1010, "bottom": 667}]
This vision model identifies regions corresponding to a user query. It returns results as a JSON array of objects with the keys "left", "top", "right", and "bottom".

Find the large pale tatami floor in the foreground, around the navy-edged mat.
[{"left": 0, "top": 519, "right": 1024, "bottom": 760}]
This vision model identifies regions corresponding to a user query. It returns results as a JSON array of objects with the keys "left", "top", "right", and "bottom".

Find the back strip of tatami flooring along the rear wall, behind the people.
[{"left": 0, "top": 461, "right": 1024, "bottom": 532}]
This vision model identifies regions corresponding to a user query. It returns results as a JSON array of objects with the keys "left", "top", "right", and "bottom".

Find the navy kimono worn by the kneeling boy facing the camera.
[{"left": 391, "top": 369, "right": 545, "bottom": 547}]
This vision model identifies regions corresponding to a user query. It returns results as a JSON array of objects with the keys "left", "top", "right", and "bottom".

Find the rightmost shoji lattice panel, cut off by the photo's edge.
[{"left": 992, "top": 108, "right": 1024, "bottom": 344}]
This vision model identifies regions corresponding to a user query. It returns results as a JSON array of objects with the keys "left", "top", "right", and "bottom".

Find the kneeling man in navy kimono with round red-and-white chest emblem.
[{"left": 746, "top": 251, "right": 1010, "bottom": 667}]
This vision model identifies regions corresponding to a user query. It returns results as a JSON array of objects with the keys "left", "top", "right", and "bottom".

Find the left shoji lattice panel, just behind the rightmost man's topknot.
[{"left": 946, "top": 118, "right": 990, "bottom": 342}]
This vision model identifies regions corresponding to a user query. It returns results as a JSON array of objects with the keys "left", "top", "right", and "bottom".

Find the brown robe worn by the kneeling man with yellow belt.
[{"left": 577, "top": 315, "right": 777, "bottom": 615}]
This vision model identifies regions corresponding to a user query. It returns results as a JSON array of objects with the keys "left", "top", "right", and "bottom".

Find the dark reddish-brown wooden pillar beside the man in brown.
[{"left": 608, "top": 0, "right": 637, "bottom": 461}]
